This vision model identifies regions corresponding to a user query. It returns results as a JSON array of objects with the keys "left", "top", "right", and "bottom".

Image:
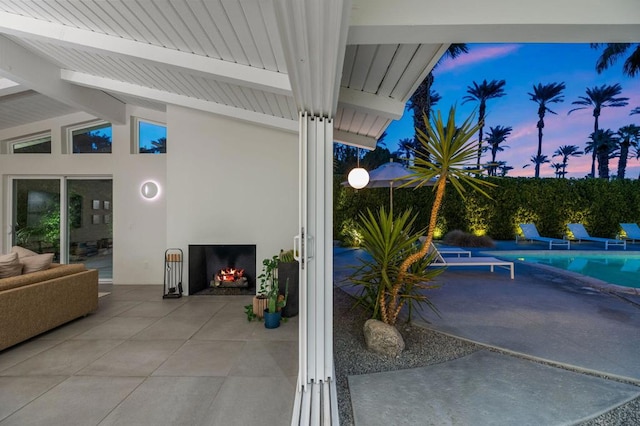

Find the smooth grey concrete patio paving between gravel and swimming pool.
[{"left": 334, "top": 245, "right": 640, "bottom": 425}]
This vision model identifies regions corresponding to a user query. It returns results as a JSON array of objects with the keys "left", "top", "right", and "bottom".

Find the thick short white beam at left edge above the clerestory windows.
[{"left": 0, "top": 36, "right": 126, "bottom": 124}]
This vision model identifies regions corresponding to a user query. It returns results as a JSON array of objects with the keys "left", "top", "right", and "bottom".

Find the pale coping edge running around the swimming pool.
[{"left": 480, "top": 250, "right": 640, "bottom": 296}]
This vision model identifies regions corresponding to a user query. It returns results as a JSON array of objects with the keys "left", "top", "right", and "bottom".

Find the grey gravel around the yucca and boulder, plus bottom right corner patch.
[{"left": 333, "top": 288, "right": 640, "bottom": 426}]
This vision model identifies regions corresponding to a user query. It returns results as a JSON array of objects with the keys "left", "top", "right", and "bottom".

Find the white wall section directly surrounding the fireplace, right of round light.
[{"left": 167, "top": 106, "right": 298, "bottom": 290}]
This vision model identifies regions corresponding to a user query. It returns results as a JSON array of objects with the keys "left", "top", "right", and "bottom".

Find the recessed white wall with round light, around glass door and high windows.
[{"left": 0, "top": 108, "right": 170, "bottom": 284}]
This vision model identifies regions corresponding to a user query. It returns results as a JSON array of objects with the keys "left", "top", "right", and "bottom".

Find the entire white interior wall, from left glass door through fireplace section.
[{"left": 0, "top": 106, "right": 298, "bottom": 290}]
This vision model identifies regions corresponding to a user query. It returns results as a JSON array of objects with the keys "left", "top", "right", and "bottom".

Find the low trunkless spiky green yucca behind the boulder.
[{"left": 349, "top": 207, "right": 442, "bottom": 320}]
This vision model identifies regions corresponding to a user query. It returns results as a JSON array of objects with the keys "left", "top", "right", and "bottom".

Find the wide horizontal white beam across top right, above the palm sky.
[{"left": 347, "top": 0, "right": 640, "bottom": 44}]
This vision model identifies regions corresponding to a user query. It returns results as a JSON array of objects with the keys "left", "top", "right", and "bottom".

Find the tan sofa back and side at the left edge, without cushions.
[{"left": 0, "top": 264, "right": 98, "bottom": 350}]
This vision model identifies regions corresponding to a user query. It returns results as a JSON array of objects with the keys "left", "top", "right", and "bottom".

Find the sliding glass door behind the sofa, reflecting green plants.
[{"left": 12, "top": 177, "right": 113, "bottom": 282}]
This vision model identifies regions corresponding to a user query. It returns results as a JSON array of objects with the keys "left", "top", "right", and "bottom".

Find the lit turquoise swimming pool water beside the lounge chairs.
[{"left": 487, "top": 250, "right": 640, "bottom": 288}]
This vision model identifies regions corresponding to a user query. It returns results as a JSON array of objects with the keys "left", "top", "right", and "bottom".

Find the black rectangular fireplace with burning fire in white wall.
[{"left": 189, "top": 244, "right": 256, "bottom": 295}]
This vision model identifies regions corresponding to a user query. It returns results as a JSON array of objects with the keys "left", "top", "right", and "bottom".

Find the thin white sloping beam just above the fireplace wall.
[{"left": 60, "top": 70, "right": 298, "bottom": 132}]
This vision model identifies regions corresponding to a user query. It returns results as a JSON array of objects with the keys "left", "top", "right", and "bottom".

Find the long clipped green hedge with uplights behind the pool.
[{"left": 334, "top": 178, "right": 640, "bottom": 245}]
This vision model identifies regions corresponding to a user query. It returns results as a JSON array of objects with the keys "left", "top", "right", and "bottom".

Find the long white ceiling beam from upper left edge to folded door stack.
[{"left": 0, "top": 12, "right": 291, "bottom": 96}]
